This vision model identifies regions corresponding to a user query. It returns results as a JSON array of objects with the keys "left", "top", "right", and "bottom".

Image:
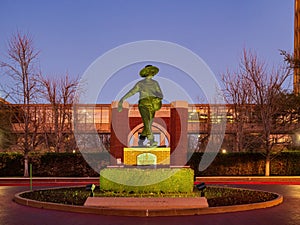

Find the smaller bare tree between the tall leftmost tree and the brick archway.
[{"left": 39, "top": 74, "right": 79, "bottom": 152}]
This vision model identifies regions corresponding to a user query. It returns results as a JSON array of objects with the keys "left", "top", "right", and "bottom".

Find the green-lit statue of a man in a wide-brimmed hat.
[{"left": 118, "top": 65, "right": 163, "bottom": 146}]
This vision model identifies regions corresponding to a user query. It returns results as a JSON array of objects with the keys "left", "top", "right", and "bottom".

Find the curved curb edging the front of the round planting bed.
[{"left": 13, "top": 191, "right": 283, "bottom": 217}]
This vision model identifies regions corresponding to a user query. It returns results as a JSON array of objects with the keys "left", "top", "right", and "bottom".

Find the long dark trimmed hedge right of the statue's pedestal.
[{"left": 188, "top": 152, "right": 300, "bottom": 176}]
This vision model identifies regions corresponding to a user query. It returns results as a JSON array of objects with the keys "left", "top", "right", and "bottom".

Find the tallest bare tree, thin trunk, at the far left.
[{"left": 0, "top": 32, "right": 41, "bottom": 176}]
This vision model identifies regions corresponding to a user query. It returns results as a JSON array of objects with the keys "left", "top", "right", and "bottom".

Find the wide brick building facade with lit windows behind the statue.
[{"left": 1, "top": 104, "right": 300, "bottom": 152}]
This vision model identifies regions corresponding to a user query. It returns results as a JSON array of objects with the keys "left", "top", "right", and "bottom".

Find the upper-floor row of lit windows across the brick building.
[{"left": 6, "top": 105, "right": 299, "bottom": 124}]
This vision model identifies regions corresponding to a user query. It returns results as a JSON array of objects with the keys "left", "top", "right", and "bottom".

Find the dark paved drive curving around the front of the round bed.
[{"left": 0, "top": 184, "right": 300, "bottom": 225}]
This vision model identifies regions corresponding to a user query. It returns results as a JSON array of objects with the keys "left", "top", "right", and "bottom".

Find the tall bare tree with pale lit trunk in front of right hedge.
[{"left": 241, "top": 50, "right": 291, "bottom": 176}]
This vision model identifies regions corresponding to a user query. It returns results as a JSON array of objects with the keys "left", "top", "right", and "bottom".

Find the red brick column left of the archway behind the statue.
[{"left": 110, "top": 101, "right": 130, "bottom": 165}]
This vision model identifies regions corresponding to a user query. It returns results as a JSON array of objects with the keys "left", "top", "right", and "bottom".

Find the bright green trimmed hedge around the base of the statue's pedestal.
[{"left": 100, "top": 168, "right": 194, "bottom": 193}]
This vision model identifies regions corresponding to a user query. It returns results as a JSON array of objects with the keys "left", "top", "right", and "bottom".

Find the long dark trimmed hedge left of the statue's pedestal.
[{"left": 0, "top": 153, "right": 109, "bottom": 177}]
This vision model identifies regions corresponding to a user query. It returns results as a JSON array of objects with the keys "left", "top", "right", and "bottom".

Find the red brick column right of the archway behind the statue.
[{"left": 170, "top": 101, "right": 188, "bottom": 166}]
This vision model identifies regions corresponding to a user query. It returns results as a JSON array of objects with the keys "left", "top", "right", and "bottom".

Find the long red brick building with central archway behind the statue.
[{"left": 3, "top": 103, "right": 300, "bottom": 154}]
